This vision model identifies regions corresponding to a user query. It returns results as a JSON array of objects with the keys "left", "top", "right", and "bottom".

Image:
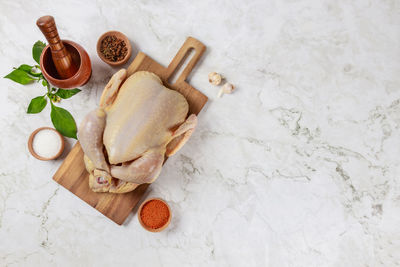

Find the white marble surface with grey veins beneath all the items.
[{"left": 0, "top": 0, "right": 400, "bottom": 266}]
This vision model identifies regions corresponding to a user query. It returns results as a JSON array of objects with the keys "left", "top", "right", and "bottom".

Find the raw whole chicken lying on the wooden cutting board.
[{"left": 78, "top": 69, "right": 197, "bottom": 193}]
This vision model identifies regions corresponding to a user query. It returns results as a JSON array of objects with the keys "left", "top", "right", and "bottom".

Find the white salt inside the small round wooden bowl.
[{"left": 32, "top": 129, "right": 61, "bottom": 158}]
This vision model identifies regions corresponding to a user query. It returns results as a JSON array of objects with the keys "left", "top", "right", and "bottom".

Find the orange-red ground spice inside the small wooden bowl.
[{"left": 140, "top": 199, "right": 170, "bottom": 229}]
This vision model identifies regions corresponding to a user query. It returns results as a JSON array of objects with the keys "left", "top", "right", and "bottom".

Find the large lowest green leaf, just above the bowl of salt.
[{"left": 50, "top": 102, "right": 77, "bottom": 139}]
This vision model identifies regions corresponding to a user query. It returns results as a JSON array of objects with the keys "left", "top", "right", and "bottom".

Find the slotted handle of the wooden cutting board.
[{"left": 167, "top": 37, "right": 206, "bottom": 83}]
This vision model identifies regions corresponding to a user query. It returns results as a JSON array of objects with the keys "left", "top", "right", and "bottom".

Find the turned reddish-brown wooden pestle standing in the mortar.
[{"left": 36, "top": 16, "right": 79, "bottom": 79}]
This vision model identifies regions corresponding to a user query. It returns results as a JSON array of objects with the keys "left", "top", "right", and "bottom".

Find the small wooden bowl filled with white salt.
[{"left": 28, "top": 127, "right": 65, "bottom": 160}]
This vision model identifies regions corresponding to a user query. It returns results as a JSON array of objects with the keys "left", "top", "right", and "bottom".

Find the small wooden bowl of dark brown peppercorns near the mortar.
[{"left": 97, "top": 31, "right": 132, "bottom": 66}]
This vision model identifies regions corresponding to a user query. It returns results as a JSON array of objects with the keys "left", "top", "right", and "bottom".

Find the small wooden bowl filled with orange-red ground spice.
[{"left": 138, "top": 198, "right": 171, "bottom": 233}]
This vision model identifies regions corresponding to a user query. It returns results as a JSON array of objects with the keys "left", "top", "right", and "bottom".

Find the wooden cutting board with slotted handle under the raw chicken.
[{"left": 53, "top": 37, "right": 207, "bottom": 225}]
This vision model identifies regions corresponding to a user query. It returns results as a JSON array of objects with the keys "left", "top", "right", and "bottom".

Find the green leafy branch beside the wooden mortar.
[{"left": 4, "top": 41, "right": 81, "bottom": 139}]
